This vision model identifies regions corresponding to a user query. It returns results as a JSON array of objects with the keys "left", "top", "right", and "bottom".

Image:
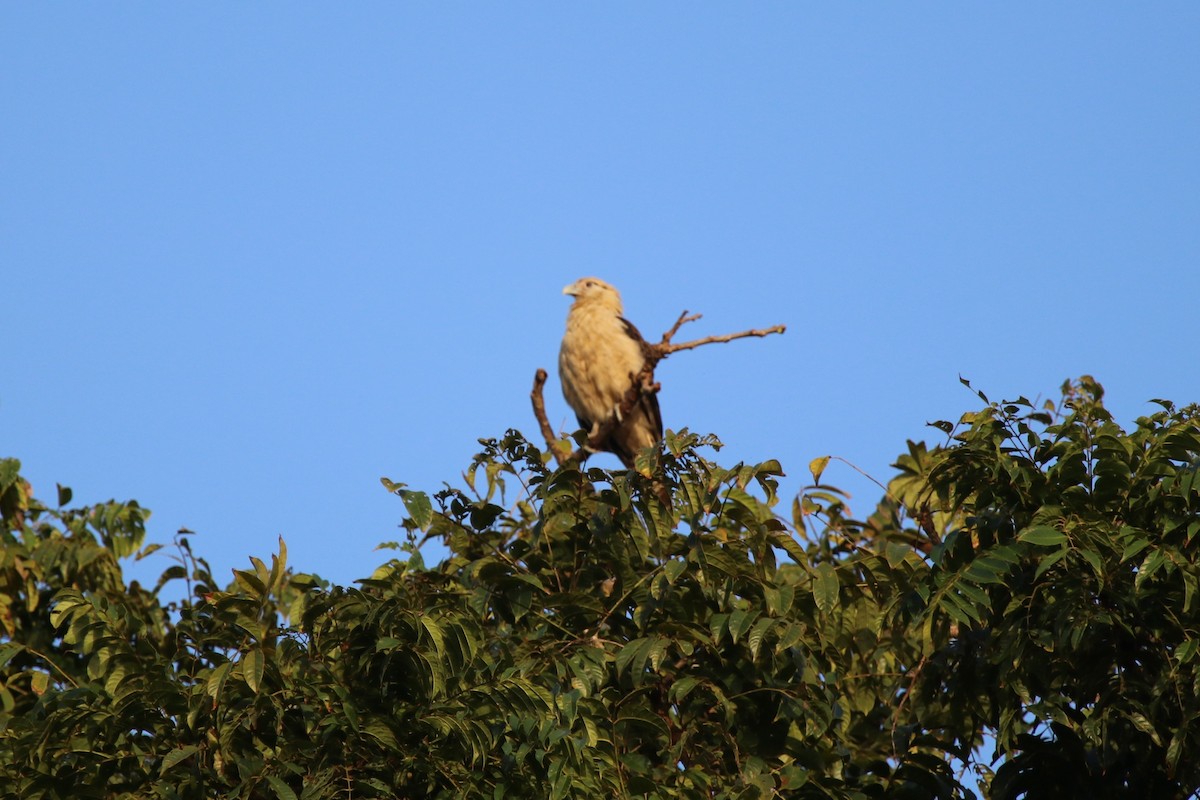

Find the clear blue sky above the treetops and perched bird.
[{"left": 0, "top": 1, "right": 1200, "bottom": 592}]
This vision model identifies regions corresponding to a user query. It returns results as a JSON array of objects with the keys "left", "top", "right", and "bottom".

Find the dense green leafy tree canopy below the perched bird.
[{"left": 0, "top": 378, "right": 1200, "bottom": 800}]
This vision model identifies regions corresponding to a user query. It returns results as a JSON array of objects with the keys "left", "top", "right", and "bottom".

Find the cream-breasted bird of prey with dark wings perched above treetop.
[{"left": 558, "top": 278, "right": 662, "bottom": 467}]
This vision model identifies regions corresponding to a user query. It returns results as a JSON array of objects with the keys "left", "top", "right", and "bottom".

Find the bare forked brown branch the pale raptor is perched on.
[{"left": 530, "top": 311, "right": 787, "bottom": 465}]
